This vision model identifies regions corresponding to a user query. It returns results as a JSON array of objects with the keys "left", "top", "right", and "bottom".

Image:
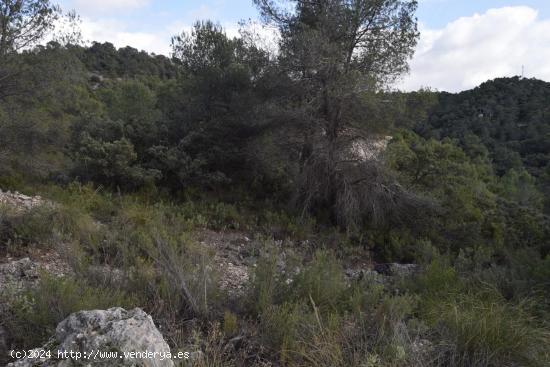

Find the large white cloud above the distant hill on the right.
[{"left": 399, "top": 6, "right": 550, "bottom": 91}]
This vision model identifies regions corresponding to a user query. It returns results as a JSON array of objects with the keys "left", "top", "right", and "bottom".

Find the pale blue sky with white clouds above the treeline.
[{"left": 57, "top": 0, "right": 550, "bottom": 92}]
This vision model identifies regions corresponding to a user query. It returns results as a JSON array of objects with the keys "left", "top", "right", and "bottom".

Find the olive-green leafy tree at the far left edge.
[{"left": 0, "top": 42, "right": 89, "bottom": 177}]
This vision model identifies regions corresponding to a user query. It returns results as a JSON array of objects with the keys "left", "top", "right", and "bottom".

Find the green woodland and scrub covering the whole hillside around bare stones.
[{"left": 0, "top": 0, "right": 550, "bottom": 367}]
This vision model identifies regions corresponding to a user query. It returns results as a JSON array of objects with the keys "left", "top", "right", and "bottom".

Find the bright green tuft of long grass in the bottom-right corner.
[{"left": 424, "top": 293, "right": 550, "bottom": 367}]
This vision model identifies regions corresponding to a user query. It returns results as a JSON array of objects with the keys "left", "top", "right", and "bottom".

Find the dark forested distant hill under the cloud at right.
[{"left": 415, "top": 77, "right": 550, "bottom": 178}]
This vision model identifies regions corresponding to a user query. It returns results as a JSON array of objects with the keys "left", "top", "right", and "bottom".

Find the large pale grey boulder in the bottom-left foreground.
[{"left": 8, "top": 308, "right": 174, "bottom": 367}]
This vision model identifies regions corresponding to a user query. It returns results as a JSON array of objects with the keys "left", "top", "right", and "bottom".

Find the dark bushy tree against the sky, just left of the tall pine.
[{"left": 168, "top": 21, "right": 267, "bottom": 190}]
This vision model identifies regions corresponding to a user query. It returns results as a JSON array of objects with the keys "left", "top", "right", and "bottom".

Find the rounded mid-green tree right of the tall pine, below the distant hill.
[{"left": 387, "top": 130, "right": 496, "bottom": 251}]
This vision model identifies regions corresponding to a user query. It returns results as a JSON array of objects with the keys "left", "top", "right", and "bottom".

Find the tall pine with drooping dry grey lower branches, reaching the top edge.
[{"left": 255, "top": 0, "right": 418, "bottom": 226}]
